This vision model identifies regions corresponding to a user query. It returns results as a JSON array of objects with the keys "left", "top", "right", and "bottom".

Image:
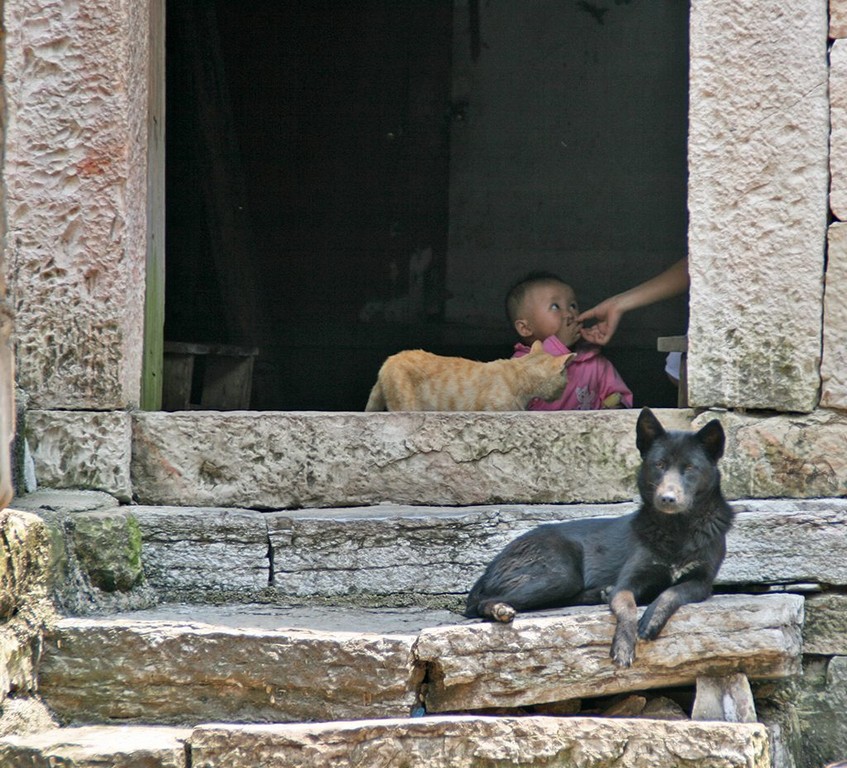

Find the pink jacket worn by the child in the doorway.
[{"left": 512, "top": 336, "right": 632, "bottom": 411}]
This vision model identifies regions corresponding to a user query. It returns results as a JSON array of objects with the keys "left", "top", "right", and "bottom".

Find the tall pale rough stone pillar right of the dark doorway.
[{"left": 688, "top": 0, "right": 829, "bottom": 411}]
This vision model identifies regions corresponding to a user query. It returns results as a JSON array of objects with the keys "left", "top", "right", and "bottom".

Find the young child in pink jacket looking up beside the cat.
[{"left": 506, "top": 272, "right": 632, "bottom": 411}]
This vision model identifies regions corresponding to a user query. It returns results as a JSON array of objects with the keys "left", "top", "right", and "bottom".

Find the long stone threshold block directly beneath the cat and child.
[{"left": 132, "top": 410, "right": 690, "bottom": 509}]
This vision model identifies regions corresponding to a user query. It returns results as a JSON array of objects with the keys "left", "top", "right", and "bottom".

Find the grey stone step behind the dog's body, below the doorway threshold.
[{"left": 11, "top": 491, "right": 847, "bottom": 612}]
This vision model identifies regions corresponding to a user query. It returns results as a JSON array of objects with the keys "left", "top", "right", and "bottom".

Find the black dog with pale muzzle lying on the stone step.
[{"left": 465, "top": 408, "right": 734, "bottom": 667}]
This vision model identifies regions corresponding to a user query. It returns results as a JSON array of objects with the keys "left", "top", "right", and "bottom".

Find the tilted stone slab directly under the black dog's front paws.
[{"left": 415, "top": 595, "right": 803, "bottom": 712}]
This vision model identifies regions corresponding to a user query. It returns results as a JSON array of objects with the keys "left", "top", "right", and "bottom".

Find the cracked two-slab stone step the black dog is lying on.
[{"left": 39, "top": 594, "right": 803, "bottom": 726}]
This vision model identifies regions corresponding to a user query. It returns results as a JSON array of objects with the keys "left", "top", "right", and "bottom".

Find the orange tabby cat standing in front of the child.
[{"left": 365, "top": 341, "right": 574, "bottom": 411}]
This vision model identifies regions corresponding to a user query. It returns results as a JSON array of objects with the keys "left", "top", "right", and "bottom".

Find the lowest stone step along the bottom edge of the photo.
[{"left": 0, "top": 716, "right": 771, "bottom": 768}]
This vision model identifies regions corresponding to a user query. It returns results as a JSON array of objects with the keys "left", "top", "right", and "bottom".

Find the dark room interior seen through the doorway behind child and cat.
[{"left": 165, "top": 0, "right": 688, "bottom": 411}]
